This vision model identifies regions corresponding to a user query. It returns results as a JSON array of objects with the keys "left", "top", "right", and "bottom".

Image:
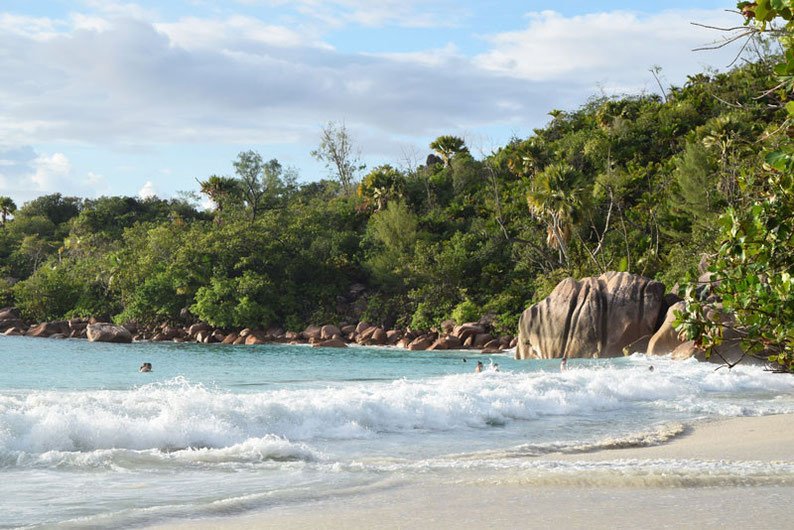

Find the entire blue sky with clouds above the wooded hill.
[{"left": 0, "top": 0, "right": 742, "bottom": 206}]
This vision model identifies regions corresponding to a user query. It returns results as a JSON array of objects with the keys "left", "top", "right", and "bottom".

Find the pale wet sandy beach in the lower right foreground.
[{"left": 153, "top": 415, "right": 794, "bottom": 529}]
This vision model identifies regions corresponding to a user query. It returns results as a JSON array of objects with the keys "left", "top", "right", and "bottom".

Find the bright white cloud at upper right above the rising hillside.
[{"left": 475, "top": 10, "right": 740, "bottom": 89}]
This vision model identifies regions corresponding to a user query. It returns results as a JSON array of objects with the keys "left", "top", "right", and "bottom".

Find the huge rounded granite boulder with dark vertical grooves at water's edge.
[{"left": 516, "top": 272, "right": 667, "bottom": 359}]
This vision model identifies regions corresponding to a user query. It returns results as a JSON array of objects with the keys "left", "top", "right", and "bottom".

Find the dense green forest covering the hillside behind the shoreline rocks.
[{"left": 0, "top": 32, "right": 790, "bottom": 342}]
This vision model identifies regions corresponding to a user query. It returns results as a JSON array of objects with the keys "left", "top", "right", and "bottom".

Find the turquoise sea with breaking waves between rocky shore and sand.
[{"left": 0, "top": 337, "right": 794, "bottom": 527}]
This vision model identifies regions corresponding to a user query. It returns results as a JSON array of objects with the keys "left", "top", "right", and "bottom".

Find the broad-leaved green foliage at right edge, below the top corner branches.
[{"left": 677, "top": 163, "right": 794, "bottom": 369}]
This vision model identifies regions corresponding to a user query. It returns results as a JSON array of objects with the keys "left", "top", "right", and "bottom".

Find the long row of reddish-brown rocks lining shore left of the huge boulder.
[{"left": 0, "top": 308, "right": 518, "bottom": 353}]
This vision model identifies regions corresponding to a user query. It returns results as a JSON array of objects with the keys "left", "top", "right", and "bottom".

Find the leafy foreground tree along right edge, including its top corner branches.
[{"left": 675, "top": 0, "right": 794, "bottom": 371}]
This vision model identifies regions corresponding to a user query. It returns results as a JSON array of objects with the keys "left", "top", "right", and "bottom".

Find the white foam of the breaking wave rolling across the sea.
[{"left": 0, "top": 357, "right": 794, "bottom": 462}]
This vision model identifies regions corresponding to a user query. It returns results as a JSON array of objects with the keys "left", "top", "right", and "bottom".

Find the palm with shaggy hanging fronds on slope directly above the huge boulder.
[{"left": 527, "top": 163, "right": 582, "bottom": 264}]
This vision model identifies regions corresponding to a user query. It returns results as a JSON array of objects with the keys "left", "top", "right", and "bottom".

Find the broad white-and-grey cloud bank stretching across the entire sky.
[{"left": 0, "top": 4, "right": 736, "bottom": 201}]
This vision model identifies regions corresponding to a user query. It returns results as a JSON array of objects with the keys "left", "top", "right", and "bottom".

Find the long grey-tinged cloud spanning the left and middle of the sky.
[{"left": 0, "top": 13, "right": 534, "bottom": 146}]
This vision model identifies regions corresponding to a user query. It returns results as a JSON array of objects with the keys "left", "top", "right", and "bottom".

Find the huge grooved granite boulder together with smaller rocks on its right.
[{"left": 516, "top": 272, "right": 751, "bottom": 363}]
